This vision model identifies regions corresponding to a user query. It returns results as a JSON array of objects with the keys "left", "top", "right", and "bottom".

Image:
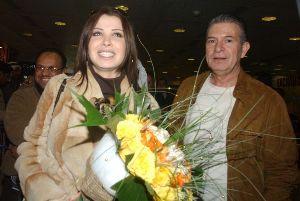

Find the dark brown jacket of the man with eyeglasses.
[{"left": 1, "top": 84, "right": 40, "bottom": 176}]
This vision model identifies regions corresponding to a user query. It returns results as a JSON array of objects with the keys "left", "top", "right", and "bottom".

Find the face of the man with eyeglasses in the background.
[{"left": 34, "top": 52, "right": 63, "bottom": 88}]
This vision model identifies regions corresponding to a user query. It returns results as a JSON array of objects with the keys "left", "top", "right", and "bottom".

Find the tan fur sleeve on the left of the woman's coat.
[{"left": 15, "top": 76, "right": 64, "bottom": 201}]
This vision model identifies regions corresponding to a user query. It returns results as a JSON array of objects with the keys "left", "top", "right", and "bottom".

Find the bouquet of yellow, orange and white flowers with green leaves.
[{"left": 73, "top": 88, "right": 203, "bottom": 201}]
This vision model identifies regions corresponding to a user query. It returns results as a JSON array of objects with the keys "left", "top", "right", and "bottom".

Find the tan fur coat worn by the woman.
[{"left": 15, "top": 70, "right": 139, "bottom": 201}]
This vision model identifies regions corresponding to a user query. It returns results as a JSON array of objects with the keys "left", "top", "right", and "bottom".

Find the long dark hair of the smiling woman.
[{"left": 75, "top": 7, "right": 138, "bottom": 88}]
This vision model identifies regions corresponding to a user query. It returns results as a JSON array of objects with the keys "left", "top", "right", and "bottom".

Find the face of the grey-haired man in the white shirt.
[{"left": 206, "top": 22, "right": 250, "bottom": 75}]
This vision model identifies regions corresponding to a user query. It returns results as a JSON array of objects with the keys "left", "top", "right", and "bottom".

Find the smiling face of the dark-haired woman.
[{"left": 88, "top": 15, "right": 126, "bottom": 78}]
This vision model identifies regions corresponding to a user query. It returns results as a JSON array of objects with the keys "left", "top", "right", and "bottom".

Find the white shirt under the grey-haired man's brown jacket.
[{"left": 184, "top": 76, "right": 235, "bottom": 201}]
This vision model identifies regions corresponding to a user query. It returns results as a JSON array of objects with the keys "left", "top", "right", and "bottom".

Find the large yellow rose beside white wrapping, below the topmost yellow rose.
[{"left": 127, "top": 146, "right": 155, "bottom": 183}]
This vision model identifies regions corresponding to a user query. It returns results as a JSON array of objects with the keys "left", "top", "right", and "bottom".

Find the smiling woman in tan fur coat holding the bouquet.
[{"left": 15, "top": 8, "right": 155, "bottom": 201}]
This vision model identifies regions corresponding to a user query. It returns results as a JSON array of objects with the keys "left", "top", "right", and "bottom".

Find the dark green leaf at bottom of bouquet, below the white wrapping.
[{"left": 112, "top": 175, "right": 152, "bottom": 201}]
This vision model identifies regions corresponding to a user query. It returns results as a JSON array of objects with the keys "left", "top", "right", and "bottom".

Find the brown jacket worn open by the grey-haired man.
[{"left": 174, "top": 71, "right": 297, "bottom": 201}]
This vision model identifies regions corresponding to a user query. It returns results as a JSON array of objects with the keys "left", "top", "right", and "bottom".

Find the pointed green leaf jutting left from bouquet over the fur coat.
[{"left": 70, "top": 89, "right": 107, "bottom": 126}]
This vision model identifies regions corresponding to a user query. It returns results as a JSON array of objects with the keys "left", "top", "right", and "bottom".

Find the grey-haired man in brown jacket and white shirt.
[{"left": 174, "top": 15, "right": 297, "bottom": 201}]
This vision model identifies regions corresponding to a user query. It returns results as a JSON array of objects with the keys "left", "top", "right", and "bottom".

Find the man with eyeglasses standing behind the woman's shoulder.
[{"left": 0, "top": 48, "right": 67, "bottom": 201}]
